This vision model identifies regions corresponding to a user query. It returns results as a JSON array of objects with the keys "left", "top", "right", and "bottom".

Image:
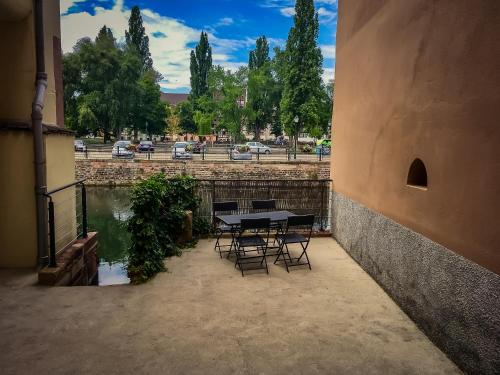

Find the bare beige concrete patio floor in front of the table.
[{"left": 0, "top": 238, "right": 460, "bottom": 374}]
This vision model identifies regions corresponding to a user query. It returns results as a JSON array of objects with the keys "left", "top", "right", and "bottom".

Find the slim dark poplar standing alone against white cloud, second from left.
[{"left": 189, "top": 32, "right": 212, "bottom": 99}]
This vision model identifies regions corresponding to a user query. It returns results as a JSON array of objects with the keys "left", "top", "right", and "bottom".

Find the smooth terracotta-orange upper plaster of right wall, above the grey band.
[{"left": 331, "top": 0, "right": 500, "bottom": 273}]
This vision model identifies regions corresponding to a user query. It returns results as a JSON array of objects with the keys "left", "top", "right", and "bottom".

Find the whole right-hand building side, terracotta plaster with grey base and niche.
[{"left": 331, "top": 0, "right": 500, "bottom": 374}]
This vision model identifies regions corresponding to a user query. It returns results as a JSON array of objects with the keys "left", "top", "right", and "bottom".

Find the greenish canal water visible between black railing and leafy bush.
[{"left": 87, "top": 186, "right": 132, "bottom": 285}]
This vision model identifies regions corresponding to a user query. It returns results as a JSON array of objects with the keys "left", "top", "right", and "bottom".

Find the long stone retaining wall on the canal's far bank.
[{"left": 75, "top": 160, "right": 330, "bottom": 185}]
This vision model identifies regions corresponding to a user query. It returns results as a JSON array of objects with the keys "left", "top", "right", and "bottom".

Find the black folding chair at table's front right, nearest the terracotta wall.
[{"left": 274, "top": 215, "right": 314, "bottom": 272}]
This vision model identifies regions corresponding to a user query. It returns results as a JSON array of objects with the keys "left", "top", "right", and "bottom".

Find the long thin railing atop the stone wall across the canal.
[{"left": 75, "top": 145, "right": 331, "bottom": 162}]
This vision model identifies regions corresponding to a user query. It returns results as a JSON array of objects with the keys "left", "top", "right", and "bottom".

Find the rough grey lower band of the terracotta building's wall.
[{"left": 331, "top": 193, "right": 500, "bottom": 374}]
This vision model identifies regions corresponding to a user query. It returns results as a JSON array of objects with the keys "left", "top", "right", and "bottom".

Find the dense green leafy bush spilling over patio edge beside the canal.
[{"left": 127, "top": 173, "right": 209, "bottom": 284}]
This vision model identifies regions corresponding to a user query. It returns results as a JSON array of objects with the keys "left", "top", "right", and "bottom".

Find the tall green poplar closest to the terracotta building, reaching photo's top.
[{"left": 280, "top": 0, "right": 323, "bottom": 150}]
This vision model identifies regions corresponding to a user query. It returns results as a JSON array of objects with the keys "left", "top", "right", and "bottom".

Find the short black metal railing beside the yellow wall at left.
[{"left": 44, "top": 179, "right": 87, "bottom": 267}]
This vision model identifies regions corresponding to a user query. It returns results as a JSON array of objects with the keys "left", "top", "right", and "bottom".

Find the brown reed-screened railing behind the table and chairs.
[{"left": 196, "top": 179, "right": 331, "bottom": 231}]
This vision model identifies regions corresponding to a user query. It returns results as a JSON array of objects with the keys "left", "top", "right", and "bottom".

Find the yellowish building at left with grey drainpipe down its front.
[{"left": 0, "top": 0, "right": 76, "bottom": 268}]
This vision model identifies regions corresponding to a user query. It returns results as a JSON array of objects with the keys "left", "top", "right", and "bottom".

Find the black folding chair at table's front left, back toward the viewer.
[{"left": 234, "top": 218, "right": 271, "bottom": 276}]
